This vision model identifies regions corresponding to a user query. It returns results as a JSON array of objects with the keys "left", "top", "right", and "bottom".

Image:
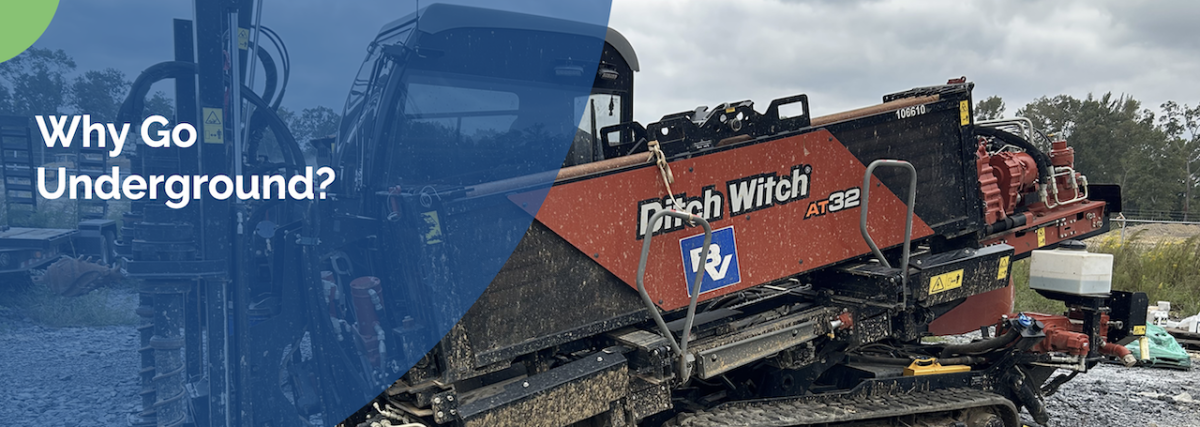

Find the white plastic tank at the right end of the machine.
[{"left": 1030, "top": 241, "right": 1112, "bottom": 295}]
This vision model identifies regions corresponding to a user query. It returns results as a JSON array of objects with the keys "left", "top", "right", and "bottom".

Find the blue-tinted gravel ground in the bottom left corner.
[{"left": 0, "top": 319, "right": 139, "bottom": 427}]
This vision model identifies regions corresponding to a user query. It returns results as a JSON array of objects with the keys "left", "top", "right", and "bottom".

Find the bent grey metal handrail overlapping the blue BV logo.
[{"left": 637, "top": 210, "right": 713, "bottom": 381}]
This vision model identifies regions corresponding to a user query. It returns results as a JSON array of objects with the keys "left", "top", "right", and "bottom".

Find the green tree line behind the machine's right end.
[{"left": 974, "top": 92, "right": 1200, "bottom": 221}]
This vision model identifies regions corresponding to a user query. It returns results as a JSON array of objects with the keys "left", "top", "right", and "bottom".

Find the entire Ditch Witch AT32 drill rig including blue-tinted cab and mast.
[{"left": 121, "top": 1, "right": 1146, "bottom": 427}]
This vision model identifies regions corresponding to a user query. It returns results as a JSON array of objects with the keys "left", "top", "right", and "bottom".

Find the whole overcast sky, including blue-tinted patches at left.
[{"left": 25, "top": 0, "right": 1200, "bottom": 124}]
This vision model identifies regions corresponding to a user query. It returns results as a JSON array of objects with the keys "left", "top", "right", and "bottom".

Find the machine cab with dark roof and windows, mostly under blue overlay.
[{"left": 334, "top": 5, "right": 638, "bottom": 193}]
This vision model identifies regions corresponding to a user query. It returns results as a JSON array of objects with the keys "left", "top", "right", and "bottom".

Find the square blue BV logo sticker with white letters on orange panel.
[{"left": 679, "top": 225, "right": 742, "bottom": 296}]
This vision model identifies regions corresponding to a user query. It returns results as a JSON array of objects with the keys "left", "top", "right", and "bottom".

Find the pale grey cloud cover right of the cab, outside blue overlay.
[{"left": 610, "top": 0, "right": 1200, "bottom": 122}]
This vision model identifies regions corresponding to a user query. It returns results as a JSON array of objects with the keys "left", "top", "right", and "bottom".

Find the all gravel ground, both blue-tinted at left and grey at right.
[{"left": 0, "top": 309, "right": 1200, "bottom": 427}]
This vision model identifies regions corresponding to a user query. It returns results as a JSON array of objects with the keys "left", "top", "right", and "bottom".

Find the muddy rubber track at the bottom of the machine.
[{"left": 674, "top": 389, "right": 1016, "bottom": 427}]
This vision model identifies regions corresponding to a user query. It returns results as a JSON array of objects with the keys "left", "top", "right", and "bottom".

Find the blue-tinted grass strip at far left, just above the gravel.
[{"left": 0, "top": 274, "right": 138, "bottom": 331}]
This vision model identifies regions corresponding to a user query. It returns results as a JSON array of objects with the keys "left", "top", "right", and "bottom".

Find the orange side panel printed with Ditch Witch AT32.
[{"left": 538, "top": 130, "right": 932, "bottom": 309}]
